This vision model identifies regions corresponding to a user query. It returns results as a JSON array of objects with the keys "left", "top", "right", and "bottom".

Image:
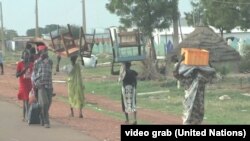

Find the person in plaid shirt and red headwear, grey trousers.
[{"left": 33, "top": 45, "right": 53, "bottom": 128}]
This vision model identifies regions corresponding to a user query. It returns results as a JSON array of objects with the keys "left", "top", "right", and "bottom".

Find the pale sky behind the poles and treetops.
[{"left": 0, "top": 0, "right": 191, "bottom": 36}]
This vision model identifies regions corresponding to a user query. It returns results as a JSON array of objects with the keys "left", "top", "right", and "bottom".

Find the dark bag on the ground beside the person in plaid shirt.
[{"left": 28, "top": 102, "right": 41, "bottom": 125}]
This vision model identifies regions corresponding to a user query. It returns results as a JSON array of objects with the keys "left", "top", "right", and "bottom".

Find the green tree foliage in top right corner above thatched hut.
[{"left": 185, "top": 0, "right": 250, "bottom": 37}]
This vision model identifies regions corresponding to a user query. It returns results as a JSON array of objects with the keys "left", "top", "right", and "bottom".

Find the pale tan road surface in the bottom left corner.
[{"left": 0, "top": 98, "right": 98, "bottom": 141}]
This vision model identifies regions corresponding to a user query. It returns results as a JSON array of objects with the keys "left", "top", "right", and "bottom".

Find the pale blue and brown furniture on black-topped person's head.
[{"left": 110, "top": 29, "right": 146, "bottom": 62}]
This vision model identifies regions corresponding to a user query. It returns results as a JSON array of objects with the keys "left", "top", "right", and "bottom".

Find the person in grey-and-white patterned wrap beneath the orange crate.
[{"left": 173, "top": 54, "right": 215, "bottom": 125}]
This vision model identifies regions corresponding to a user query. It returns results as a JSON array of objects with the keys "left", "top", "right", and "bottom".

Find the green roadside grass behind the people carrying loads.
[{"left": 85, "top": 65, "right": 250, "bottom": 124}]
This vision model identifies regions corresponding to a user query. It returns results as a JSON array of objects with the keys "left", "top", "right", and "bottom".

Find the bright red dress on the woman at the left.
[{"left": 16, "top": 61, "right": 33, "bottom": 100}]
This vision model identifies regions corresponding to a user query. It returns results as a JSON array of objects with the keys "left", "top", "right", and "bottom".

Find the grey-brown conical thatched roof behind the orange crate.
[{"left": 172, "top": 26, "right": 240, "bottom": 62}]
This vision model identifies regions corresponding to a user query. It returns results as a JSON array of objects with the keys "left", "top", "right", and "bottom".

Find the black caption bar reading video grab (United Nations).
[{"left": 121, "top": 125, "right": 250, "bottom": 141}]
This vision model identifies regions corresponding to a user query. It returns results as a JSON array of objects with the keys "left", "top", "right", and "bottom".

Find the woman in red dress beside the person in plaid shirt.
[{"left": 16, "top": 49, "right": 33, "bottom": 121}]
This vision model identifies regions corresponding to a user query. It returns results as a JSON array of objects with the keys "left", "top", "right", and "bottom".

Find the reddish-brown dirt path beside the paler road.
[{"left": 0, "top": 64, "right": 181, "bottom": 141}]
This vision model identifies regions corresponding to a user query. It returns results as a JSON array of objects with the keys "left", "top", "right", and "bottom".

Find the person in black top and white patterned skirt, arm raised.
[{"left": 111, "top": 62, "right": 138, "bottom": 124}]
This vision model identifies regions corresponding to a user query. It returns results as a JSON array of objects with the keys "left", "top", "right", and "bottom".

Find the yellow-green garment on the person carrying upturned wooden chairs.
[{"left": 67, "top": 64, "right": 85, "bottom": 108}]
